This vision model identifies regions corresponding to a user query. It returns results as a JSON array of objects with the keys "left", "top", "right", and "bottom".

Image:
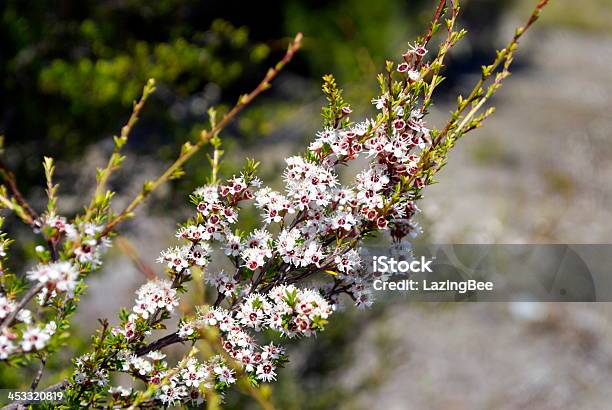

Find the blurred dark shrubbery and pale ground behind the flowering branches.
[{"left": 0, "top": 0, "right": 612, "bottom": 410}]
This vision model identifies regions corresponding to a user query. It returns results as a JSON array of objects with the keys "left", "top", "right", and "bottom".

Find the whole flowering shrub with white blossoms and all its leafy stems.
[{"left": 0, "top": 0, "right": 546, "bottom": 408}]
